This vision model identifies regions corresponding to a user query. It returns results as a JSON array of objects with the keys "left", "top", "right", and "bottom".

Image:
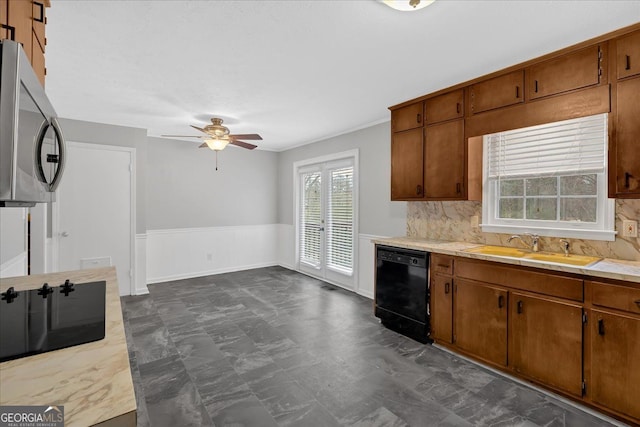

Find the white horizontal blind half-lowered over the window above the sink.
[{"left": 485, "top": 114, "right": 607, "bottom": 179}]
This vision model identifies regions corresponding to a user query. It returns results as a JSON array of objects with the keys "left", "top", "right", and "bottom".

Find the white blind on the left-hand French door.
[{"left": 300, "top": 171, "right": 322, "bottom": 268}]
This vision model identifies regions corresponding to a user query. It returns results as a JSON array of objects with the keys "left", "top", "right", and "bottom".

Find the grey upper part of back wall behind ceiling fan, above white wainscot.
[{"left": 146, "top": 137, "right": 278, "bottom": 230}]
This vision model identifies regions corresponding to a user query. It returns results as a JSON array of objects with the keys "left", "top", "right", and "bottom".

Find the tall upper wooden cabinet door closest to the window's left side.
[{"left": 424, "top": 120, "right": 465, "bottom": 200}]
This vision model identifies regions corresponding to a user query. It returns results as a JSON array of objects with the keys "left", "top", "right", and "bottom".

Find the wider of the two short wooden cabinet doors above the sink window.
[{"left": 528, "top": 46, "right": 603, "bottom": 99}]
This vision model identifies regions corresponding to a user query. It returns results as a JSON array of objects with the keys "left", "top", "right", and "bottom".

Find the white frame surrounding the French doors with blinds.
[{"left": 293, "top": 148, "right": 360, "bottom": 292}]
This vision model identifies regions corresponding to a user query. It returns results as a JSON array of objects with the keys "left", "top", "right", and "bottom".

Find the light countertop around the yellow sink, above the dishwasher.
[{"left": 372, "top": 237, "right": 640, "bottom": 283}]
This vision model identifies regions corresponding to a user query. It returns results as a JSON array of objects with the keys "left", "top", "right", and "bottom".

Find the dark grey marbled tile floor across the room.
[{"left": 122, "top": 267, "right": 624, "bottom": 427}]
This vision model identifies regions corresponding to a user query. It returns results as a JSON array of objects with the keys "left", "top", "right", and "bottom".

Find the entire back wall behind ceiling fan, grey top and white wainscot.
[{"left": 145, "top": 137, "right": 278, "bottom": 283}]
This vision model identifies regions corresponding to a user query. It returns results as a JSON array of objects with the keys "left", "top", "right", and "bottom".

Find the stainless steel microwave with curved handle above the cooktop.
[{"left": 0, "top": 40, "right": 65, "bottom": 207}]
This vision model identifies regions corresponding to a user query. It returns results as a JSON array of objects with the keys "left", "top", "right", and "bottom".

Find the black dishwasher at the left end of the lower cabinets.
[{"left": 375, "top": 245, "right": 431, "bottom": 343}]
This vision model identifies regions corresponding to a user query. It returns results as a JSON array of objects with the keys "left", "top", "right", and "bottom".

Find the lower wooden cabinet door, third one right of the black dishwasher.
[{"left": 509, "top": 292, "right": 582, "bottom": 396}]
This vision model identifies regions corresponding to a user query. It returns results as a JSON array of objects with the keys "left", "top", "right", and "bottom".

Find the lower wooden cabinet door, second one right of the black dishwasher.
[{"left": 453, "top": 279, "right": 508, "bottom": 366}]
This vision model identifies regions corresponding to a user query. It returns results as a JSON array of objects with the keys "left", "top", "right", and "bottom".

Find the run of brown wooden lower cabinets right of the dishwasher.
[{"left": 430, "top": 254, "right": 640, "bottom": 426}]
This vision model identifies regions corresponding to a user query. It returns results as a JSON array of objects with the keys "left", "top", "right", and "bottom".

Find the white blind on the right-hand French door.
[{"left": 327, "top": 167, "right": 353, "bottom": 274}]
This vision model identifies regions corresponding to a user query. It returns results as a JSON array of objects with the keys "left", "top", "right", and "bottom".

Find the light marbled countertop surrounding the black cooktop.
[{"left": 0, "top": 267, "right": 136, "bottom": 427}]
